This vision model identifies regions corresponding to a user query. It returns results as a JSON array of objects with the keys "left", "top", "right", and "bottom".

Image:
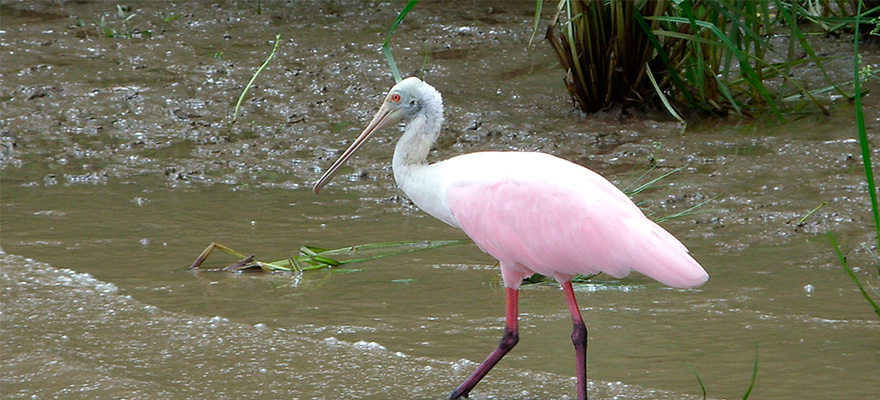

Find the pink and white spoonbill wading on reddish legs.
[{"left": 313, "top": 78, "right": 709, "bottom": 400}]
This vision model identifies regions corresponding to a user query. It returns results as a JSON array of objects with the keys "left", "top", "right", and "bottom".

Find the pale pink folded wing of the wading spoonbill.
[{"left": 447, "top": 155, "right": 709, "bottom": 287}]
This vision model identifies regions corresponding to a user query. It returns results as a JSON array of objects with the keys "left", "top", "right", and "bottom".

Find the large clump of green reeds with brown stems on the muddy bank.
[{"left": 537, "top": 0, "right": 876, "bottom": 122}]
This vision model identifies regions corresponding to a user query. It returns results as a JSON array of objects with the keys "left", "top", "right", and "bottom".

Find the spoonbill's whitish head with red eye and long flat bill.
[{"left": 312, "top": 77, "right": 443, "bottom": 194}]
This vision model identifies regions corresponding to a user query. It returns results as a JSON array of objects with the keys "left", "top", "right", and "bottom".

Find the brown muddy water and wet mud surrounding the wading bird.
[{"left": 0, "top": 1, "right": 880, "bottom": 399}]
